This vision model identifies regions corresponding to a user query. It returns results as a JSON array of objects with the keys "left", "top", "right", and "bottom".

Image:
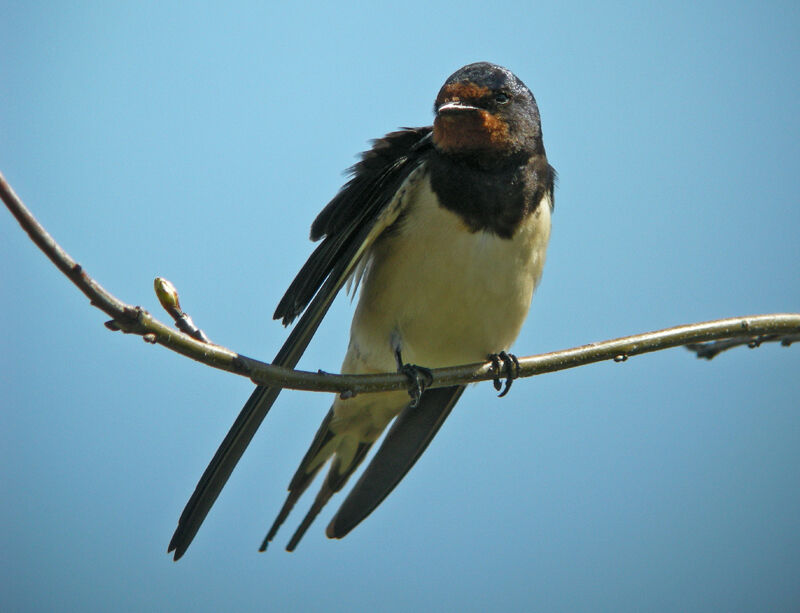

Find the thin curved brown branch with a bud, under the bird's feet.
[{"left": 0, "top": 167, "right": 800, "bottom": 395}]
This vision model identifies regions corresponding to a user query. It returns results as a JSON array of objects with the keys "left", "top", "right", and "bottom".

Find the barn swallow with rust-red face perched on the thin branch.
[{"left": 168, "top": 62, "right": 555, "bottom": 560}]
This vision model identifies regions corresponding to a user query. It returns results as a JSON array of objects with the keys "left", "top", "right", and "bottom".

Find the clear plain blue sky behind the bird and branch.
[{"left": 0, "top": 0, "right": 800, "bottom": 611}]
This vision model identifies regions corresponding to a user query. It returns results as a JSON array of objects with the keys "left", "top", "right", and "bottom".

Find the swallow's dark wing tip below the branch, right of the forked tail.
[{"left": 325, "top": 385, "right": 465, "bottom": 538}]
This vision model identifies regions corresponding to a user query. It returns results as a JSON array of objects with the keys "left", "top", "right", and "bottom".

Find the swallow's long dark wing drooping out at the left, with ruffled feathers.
[{"left": 167, "top": 127, "right": 432, "bottom": 560}]
